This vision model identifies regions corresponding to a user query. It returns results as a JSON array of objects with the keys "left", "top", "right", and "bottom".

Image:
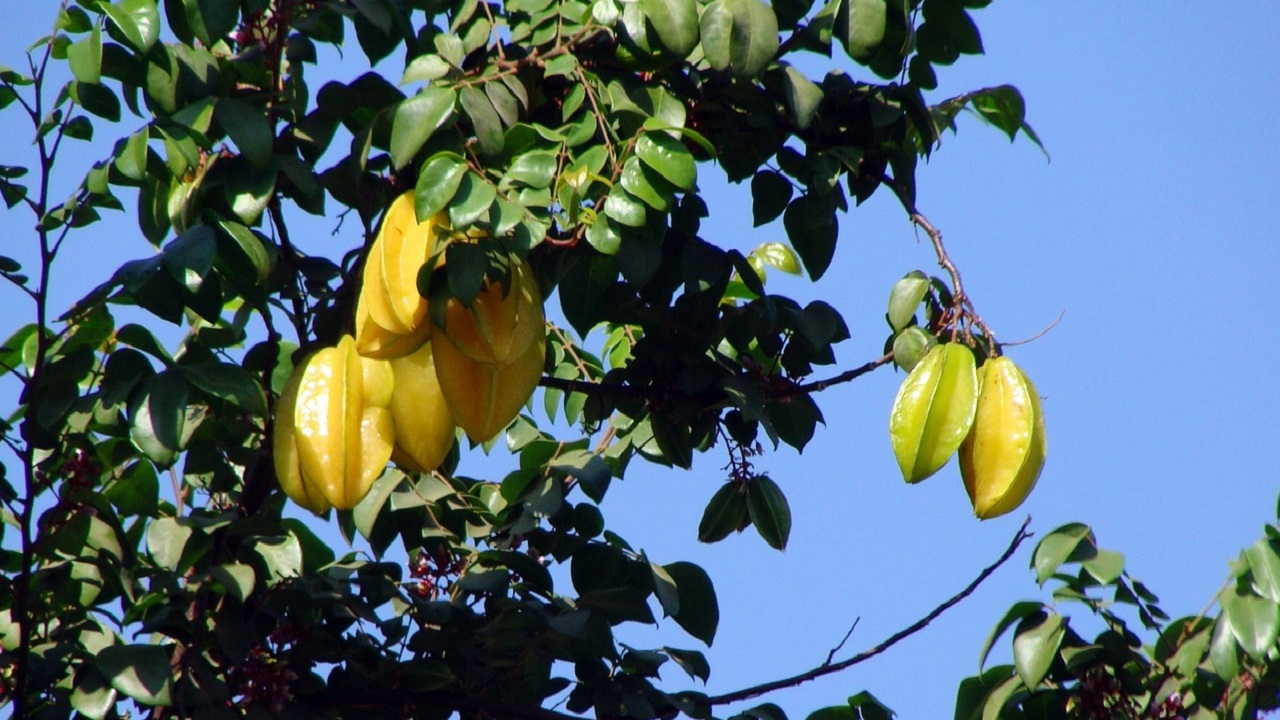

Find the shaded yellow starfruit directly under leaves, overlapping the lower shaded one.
[{"left": 442, "top": 254, "right": 547, "bottom": 365}]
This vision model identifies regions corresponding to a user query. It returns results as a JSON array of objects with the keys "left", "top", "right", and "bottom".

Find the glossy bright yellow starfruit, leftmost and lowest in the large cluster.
[{"left": 273, "top": 336, "right": 396, "bottom": 514}]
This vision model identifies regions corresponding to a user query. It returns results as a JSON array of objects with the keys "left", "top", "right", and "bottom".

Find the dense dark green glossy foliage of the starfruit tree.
[{"left": 0, "top": 0, "right": 1280, "bottom": 720}]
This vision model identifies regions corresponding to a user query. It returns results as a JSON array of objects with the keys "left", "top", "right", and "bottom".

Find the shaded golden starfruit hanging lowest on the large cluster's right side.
[{"left": 431, "top": 325, "right": 547, "bottom": 442}]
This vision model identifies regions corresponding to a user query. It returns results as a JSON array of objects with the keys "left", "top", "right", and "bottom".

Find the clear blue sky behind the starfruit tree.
[{"left": 0, "top": 1, "right": 1280, "bottom": 719}]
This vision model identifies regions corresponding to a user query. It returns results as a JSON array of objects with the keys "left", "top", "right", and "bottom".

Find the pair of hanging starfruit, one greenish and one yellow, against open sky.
[{"left": 890, "top": 273, "right": 1047, "bottom": 520}]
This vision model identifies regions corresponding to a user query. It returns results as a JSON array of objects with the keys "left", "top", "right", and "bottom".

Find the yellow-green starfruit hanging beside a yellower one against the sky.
[{"left": 888, "top": 342, "right": 978, "bottom": 483}]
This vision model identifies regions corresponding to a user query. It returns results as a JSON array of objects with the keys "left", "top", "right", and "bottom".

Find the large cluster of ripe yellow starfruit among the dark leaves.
[{"left": 273, "top": 193, "right": 547, "bottom": 514}]
